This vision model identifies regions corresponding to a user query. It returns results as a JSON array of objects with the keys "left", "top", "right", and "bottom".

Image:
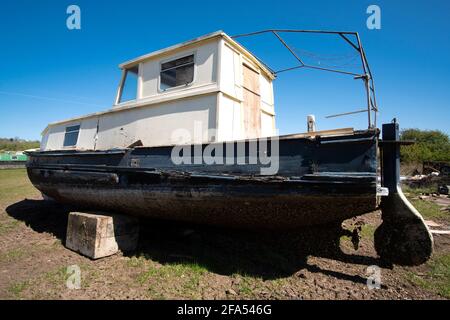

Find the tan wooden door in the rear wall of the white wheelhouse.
[{"left": 243, "top": 64, "right": 261, "bottom": 138}]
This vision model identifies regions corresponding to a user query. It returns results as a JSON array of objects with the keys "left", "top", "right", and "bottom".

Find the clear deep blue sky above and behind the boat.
[{"left": 0, "top": 0, "right": 450, "bottom": 139}]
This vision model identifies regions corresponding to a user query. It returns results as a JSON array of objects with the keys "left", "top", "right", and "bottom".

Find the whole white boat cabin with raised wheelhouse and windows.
[{"left": 41, "top": 31, "right": 275, "bottom": 151}]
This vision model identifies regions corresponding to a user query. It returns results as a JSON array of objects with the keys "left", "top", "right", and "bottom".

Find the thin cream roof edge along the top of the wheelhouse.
[{"left": 119, "top": 30, "right": 275, "bottom": 80}]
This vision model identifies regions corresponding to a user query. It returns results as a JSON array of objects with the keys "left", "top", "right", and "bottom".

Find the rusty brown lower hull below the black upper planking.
[{"left": 27, "top": 174, "right": 377, "bottom": 228}]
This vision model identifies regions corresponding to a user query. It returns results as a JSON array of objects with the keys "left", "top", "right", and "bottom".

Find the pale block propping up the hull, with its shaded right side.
[{"left": 66, "top": 212, "right": 139, "bottom": 259}]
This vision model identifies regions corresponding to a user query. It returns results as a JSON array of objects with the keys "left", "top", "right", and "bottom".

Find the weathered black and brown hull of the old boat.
[{"left": 27, "top": 131, "right": 378, "bottom": 229}]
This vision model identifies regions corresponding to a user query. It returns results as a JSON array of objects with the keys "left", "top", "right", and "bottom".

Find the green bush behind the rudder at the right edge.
[{"left": 400, "top": 129, "right": 450, "bottom": 163}]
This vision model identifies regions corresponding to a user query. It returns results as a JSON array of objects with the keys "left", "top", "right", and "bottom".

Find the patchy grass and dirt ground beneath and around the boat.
[{"left": 0, "top": 170, "right": 450, "bottom": 299}]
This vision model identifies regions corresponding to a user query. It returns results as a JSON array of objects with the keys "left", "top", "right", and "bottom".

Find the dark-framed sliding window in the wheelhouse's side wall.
[{"left": 160, "top": 54, "right": 194, "bottom": 90}]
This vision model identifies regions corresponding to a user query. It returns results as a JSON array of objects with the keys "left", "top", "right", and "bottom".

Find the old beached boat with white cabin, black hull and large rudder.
[{"left": 27, "top": 30, "right": 432, "bottom": 263}]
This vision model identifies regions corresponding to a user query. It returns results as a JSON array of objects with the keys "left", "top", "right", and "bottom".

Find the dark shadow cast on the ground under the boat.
[{"left": 6, "top": 200, "right": 381, "bottom": 283}]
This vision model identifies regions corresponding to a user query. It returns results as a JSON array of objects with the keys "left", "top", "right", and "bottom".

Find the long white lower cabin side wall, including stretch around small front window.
[{"left": 41, "top": 94, "right": 217, "bottom": 150}]
